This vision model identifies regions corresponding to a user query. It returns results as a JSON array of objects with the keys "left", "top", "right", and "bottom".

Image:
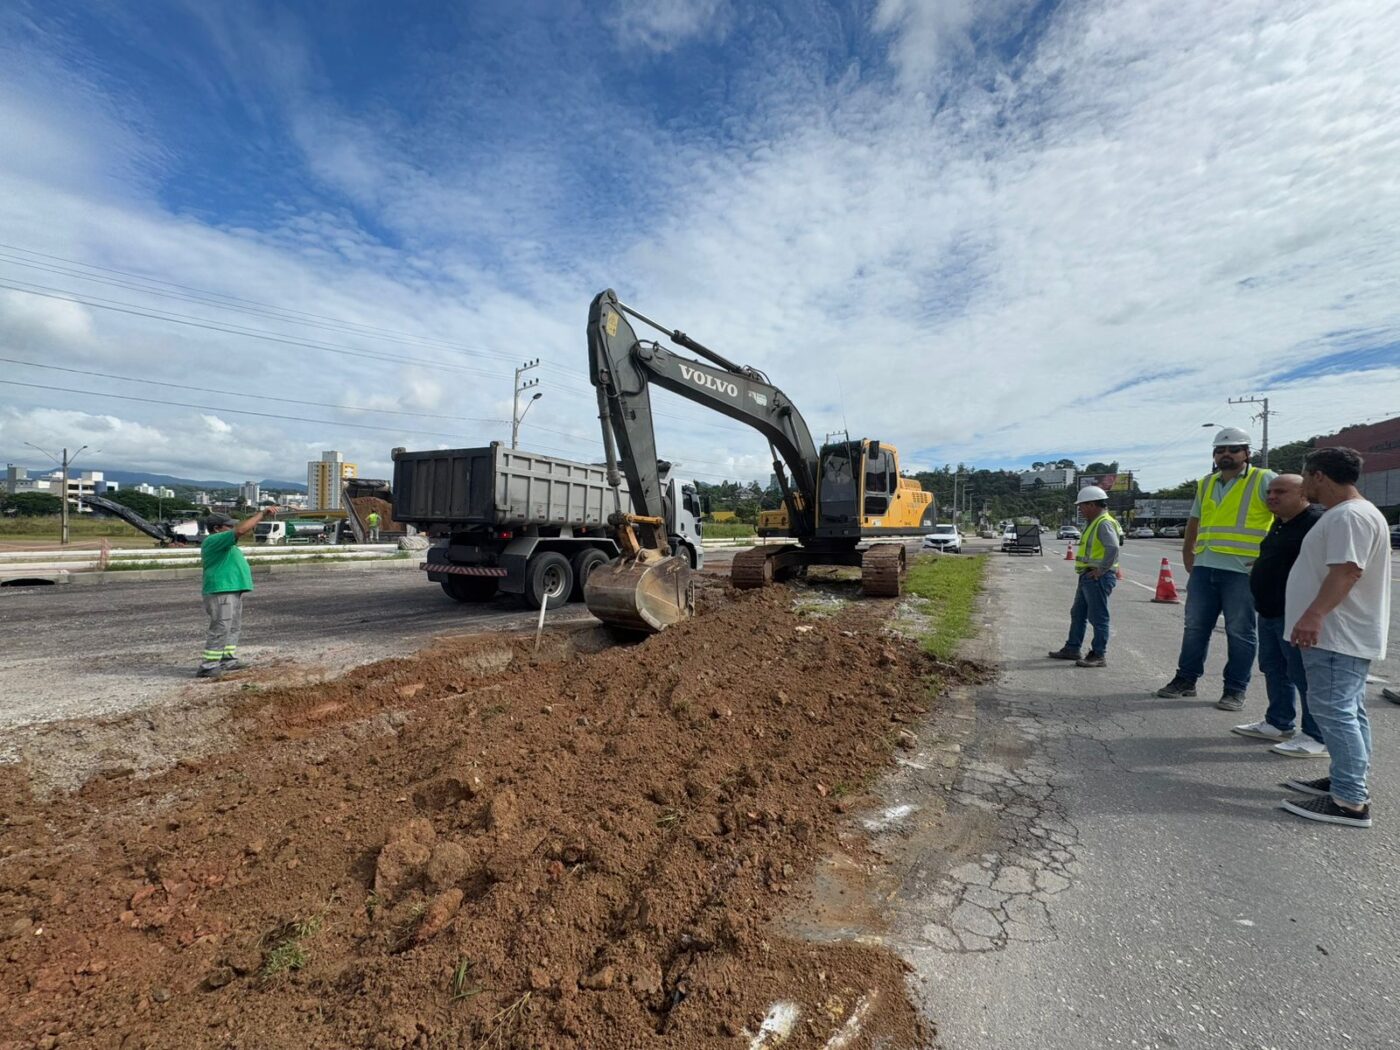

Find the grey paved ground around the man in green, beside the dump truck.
[{"left": 0, "top": 550, "right": 732, "bottom": 733}]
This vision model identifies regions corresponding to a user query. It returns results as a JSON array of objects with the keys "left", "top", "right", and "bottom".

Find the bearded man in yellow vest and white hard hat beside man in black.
[{"left": 1156, "top": 427, "right": 1274, "bottom": 711}]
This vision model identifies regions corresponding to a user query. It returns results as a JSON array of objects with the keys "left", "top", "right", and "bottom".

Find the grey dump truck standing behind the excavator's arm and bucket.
[{"left": 393, "top": 441, "right": 704, "bottom": 609}]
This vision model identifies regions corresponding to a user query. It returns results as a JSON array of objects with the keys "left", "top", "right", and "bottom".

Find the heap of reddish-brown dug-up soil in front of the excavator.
[{"left": 0, "top": 588, "right": 952, "bottom": 1050}]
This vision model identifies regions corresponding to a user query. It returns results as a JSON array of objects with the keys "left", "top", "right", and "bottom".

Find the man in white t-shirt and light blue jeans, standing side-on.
[{"left": 1282, "top": 448, "right": 1390, "bottom": 827}]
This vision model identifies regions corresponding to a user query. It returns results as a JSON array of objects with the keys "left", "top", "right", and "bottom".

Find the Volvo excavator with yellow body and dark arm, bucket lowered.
[{"left": 584, "top": 288, "right": 932, "bottom": 631}]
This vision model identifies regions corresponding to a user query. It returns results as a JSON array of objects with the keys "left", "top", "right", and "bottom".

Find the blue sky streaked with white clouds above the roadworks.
[{"left": 0, "top": 0, "right": 1400, "bottom": 484}]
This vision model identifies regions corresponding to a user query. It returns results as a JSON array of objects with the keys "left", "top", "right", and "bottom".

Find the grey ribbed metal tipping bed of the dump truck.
[{"left": 393, "top": 442, "right": 616, "bottom": 529}]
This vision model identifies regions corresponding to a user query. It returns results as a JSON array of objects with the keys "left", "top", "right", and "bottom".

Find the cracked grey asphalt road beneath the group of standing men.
[{"left": 907, "top": 540, "right": 1400, "bottom": 1050}]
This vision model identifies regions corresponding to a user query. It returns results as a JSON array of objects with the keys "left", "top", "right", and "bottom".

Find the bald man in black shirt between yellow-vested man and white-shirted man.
[{"left": 1231, "top": 475, "right": 1327, "bottom": 759}]
